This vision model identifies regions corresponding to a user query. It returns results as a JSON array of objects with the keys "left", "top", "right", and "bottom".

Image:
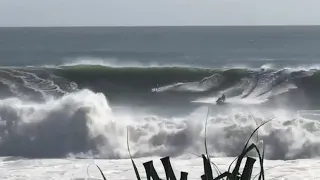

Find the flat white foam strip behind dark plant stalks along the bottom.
[{"left": 0, "top": 157, "right": 320, "bottom": 180}]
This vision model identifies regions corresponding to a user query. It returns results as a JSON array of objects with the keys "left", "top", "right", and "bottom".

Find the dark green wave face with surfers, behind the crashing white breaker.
[{"left": 0, "top": 65, "right": 320, "bottom": 104}]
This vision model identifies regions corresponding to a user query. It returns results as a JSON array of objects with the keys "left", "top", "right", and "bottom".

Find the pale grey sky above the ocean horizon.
[{"left": 0, "top": 0, "right": 320, "bottom": 26}]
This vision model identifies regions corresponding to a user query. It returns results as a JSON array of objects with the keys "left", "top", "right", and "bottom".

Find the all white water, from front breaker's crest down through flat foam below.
[{"left": 0, "top": 86, "right": 320, "bottom": 179}]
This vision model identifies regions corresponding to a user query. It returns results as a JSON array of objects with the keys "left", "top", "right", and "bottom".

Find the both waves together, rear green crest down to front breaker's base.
[{"left": 0, "top": 65, "right": 320, "bottom": 159}]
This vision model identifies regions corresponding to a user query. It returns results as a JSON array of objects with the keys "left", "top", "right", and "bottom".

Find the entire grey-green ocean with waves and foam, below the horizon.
[{"left": 0, "top": 26, "right": 320, "bottom": 179}]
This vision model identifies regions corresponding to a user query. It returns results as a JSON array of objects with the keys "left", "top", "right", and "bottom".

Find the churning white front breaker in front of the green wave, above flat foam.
[{"left": 0, "top": 90, "right": 320, "bottom": 159}]
